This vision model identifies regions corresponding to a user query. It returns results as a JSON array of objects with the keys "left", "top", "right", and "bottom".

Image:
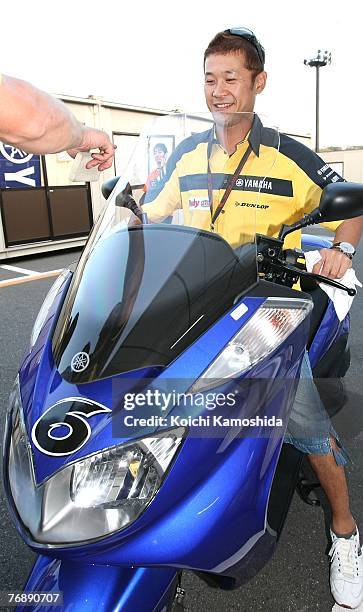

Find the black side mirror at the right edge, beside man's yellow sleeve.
[{"left": 279, "top": 182, "right": 363, "bottom": 240}]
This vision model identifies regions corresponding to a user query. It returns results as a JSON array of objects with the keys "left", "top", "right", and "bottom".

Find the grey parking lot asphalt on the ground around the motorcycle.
[{"left": 0, "top": 241, "right": 363, "bottom": 612}]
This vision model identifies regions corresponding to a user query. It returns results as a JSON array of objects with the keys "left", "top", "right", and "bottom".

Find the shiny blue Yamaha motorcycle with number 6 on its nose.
[{"left": 4, "top": 115, "right": 363, "bottom": 612}]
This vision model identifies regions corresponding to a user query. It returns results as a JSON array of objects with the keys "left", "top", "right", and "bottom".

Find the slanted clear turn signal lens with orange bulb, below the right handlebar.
[{"left": 189, "top": 298, "right": 313, "bottom": 393}]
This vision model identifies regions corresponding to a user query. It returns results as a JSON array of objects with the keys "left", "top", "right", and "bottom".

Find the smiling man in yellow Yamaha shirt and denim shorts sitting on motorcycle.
[{"left": 143, "top": 28, "right": 363, "bottom": 608}]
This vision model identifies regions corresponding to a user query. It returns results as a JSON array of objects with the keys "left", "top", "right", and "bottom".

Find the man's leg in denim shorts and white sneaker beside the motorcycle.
[{"left": 285, "top": 353, "right": 363, "bottom": 608}]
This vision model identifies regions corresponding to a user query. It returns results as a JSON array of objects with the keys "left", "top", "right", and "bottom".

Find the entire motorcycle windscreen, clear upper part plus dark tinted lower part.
[{"left": 53, "top": 113, "right": 277, "bottom": 383}]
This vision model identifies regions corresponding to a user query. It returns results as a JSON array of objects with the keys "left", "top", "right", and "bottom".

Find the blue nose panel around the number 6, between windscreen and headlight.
[{"left": 19, "top": 290, "right": 264, "bottom": 483}]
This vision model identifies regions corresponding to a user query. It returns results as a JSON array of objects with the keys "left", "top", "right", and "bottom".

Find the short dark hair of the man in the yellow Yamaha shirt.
[{"left": 204, "top": 32, "right": 263, "bottom": 78}]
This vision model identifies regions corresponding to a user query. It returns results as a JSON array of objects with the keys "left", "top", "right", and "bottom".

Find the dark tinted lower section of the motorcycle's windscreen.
[{"left": 53, "top": 225, "right": 256, "bottom": 383}]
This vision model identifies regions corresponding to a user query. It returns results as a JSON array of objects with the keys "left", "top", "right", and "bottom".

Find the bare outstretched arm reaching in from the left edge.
[{"left": 0, "top": 75, "right": 115, "bottom": 171}]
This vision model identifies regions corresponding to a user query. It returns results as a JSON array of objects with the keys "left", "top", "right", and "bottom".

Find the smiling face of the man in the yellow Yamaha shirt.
[{"left": 204, "top": 53, "right": 266, "bottom": 125}]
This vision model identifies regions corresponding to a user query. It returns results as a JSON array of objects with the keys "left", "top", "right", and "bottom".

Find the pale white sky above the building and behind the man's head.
[{"left": 0, "top": 0, "right": 363, "bottom": 147}]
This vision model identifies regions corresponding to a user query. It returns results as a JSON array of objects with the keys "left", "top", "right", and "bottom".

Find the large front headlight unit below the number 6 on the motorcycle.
[{"left": 4, "top": 386, "right": 186, "bottom": 546}]
